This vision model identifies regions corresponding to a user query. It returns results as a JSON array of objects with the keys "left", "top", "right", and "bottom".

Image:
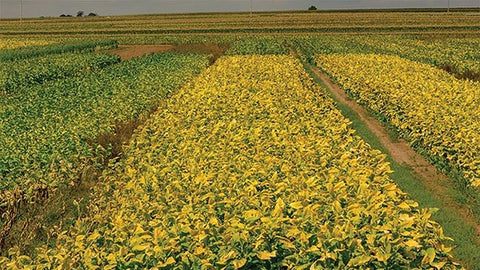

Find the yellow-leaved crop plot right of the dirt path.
[{"left": 315, "top": 54, "right": 480, "bottom": 187}]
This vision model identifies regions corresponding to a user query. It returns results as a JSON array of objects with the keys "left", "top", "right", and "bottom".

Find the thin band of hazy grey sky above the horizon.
[{"left": 0, "top": 0, "right": 480, "bottom": 18}]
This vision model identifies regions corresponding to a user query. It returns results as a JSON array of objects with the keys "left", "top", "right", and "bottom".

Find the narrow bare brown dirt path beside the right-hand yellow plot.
[{"left": 307, "top": 61, "right": 480, "bottom": 238}]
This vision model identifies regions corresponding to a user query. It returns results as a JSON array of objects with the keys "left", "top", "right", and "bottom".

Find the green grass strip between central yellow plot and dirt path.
[{"left": 304, "top": 59, "right": 480, "bottom": 269}]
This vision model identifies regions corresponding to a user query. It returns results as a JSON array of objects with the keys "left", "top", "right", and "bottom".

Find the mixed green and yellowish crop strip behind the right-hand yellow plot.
[{"left": 292, "top": 35, "right": 480, "bottom": 77}]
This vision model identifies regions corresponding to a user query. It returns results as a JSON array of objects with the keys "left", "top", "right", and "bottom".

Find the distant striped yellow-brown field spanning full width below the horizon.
[{"left": 0, "top": 10, "right": 480, "bottom": 36}]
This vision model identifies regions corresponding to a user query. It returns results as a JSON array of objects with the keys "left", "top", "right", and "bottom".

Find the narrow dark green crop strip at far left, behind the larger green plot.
[{"left": 0, "top": 40, "right": 118, "bottom": 61}]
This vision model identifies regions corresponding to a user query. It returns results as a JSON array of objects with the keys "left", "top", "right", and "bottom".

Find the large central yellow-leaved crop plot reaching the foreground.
[{"left": 0, "top": 56, "right": 456, "bottom": 269}]
